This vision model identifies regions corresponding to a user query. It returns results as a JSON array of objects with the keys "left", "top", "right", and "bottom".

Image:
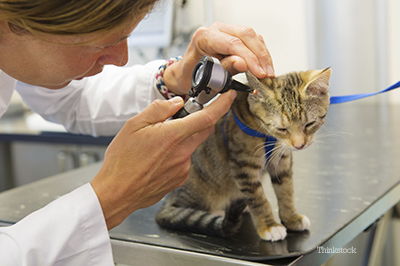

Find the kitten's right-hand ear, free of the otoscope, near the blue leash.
[{"left": 303, "top": 67, "right": 332, "bottom": 96}]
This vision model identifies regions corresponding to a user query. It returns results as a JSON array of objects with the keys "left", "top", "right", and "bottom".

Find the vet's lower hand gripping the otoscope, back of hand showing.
[{"left": 91, "top": 91, "right": 236, "bottom": 229}]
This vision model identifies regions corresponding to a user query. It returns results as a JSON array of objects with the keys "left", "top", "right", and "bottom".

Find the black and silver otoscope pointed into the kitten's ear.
[{"left": 172, "top": 56, "right": 253, "bottom": 119}]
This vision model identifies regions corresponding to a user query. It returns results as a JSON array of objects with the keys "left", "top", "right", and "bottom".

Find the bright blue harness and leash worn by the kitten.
[{"left": 222, "top": 78, "right": 400, "bottom": 162}]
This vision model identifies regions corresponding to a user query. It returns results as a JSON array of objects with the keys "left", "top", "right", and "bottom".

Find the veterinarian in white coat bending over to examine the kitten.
[{"left": 0, "top": 0, "right": 274, "bottom": 266}]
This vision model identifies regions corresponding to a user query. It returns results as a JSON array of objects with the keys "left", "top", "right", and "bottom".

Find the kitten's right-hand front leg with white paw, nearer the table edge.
[{"left": 268, "top": 153, "right": 310, "bottom": 231}]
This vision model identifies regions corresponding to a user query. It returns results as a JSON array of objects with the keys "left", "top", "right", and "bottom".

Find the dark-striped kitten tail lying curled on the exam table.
[{"left": 156, "top": 199, "right": 247, "bottom": 237}]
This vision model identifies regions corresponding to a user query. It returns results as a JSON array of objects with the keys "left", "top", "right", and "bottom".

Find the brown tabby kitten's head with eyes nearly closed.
[{"left": 246, "top": 68, "right": 331, "bottom": 150}]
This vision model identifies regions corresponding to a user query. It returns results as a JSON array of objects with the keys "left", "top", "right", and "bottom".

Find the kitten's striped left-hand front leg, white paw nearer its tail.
[{"left": 236, "top": 168, "right": 286, "bottom": 241}]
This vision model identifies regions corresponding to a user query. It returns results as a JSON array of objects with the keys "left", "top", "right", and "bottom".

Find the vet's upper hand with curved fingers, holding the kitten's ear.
[{"left": 164, "top": 22, "right": 275, "bottom": 95}]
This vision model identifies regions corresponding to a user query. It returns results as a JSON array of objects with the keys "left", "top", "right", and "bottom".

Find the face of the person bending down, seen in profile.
[{"left": 0, "top": 15, "right": 144, "bottom": 89}]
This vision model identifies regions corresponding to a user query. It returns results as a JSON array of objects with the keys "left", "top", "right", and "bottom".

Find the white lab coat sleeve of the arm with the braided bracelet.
[{"left": 16, "top": 60, "right": 165, "bottom": 136}]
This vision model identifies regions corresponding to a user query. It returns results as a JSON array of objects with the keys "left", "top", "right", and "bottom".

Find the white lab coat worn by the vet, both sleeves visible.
[{"left": 0, "top": 61, "right": 163, "bottom": 266}]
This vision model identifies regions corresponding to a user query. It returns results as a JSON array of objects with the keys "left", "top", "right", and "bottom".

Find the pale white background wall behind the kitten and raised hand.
[{"left": 127, "top": 0, "right": 400, "bottom": 104}]
